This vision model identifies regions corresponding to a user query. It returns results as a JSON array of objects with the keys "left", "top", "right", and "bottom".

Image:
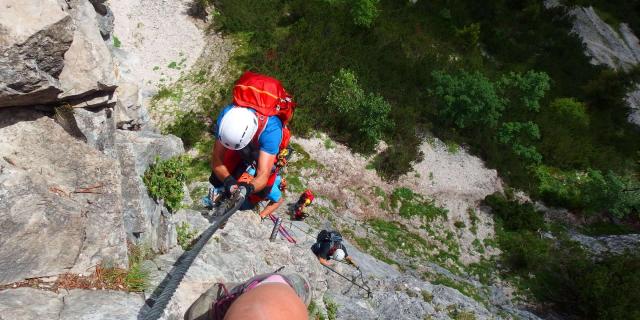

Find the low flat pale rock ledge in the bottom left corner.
[{"left": 0, "top": 288, "right": 144, "bottom": 320}]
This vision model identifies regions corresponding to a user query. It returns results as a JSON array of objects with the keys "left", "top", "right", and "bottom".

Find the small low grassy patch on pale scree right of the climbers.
[{"left": 391, "top": 188, "right": 448, "bottom": 222}]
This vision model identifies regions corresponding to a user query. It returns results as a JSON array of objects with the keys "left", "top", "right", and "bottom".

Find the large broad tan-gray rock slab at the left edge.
[{"left": 0, "top": 110, "right": 127, "bottom": 284}]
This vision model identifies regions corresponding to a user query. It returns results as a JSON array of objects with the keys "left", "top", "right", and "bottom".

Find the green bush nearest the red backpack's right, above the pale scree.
[{"left": 326, "top": 69, "right": 393, "bottom": 152}]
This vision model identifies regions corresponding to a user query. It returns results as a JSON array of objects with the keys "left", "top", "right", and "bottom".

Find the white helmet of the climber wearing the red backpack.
[{"left": 218, "top": 107, "right": 258, "bottom": 150}]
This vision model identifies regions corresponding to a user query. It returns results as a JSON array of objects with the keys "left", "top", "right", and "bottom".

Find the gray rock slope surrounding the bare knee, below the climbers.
[{"left": 149, "top": 210, "right": 516, "bottom": 320}]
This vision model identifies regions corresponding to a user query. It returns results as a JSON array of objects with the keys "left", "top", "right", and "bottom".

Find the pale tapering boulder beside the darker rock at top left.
[{"left": 58, "top": 0, "right": 116, "bottom": 100}]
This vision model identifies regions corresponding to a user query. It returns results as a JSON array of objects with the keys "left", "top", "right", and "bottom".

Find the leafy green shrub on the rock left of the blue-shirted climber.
[{"left": 142, "top": 156, "right": 187, "bottom": 212}]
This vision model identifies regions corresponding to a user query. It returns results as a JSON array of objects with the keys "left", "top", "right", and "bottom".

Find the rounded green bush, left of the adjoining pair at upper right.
[{"left": 431, "top": 71, "right": 505, "bottom": 129}]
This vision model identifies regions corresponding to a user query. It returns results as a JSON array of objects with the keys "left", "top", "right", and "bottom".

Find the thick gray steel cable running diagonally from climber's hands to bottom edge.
[{"left": 143, "top": 187, "right": 247, "bottom": 320}]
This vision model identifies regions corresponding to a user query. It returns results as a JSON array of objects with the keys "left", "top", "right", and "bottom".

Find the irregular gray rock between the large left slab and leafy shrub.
[{"left": 74, "top": 108, "right": 184, "bottom": 252}]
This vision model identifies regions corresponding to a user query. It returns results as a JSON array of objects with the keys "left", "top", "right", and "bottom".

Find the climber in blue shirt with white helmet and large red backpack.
[{"left": 209, "top": 71, "right": 295, "bottom": 209}]
